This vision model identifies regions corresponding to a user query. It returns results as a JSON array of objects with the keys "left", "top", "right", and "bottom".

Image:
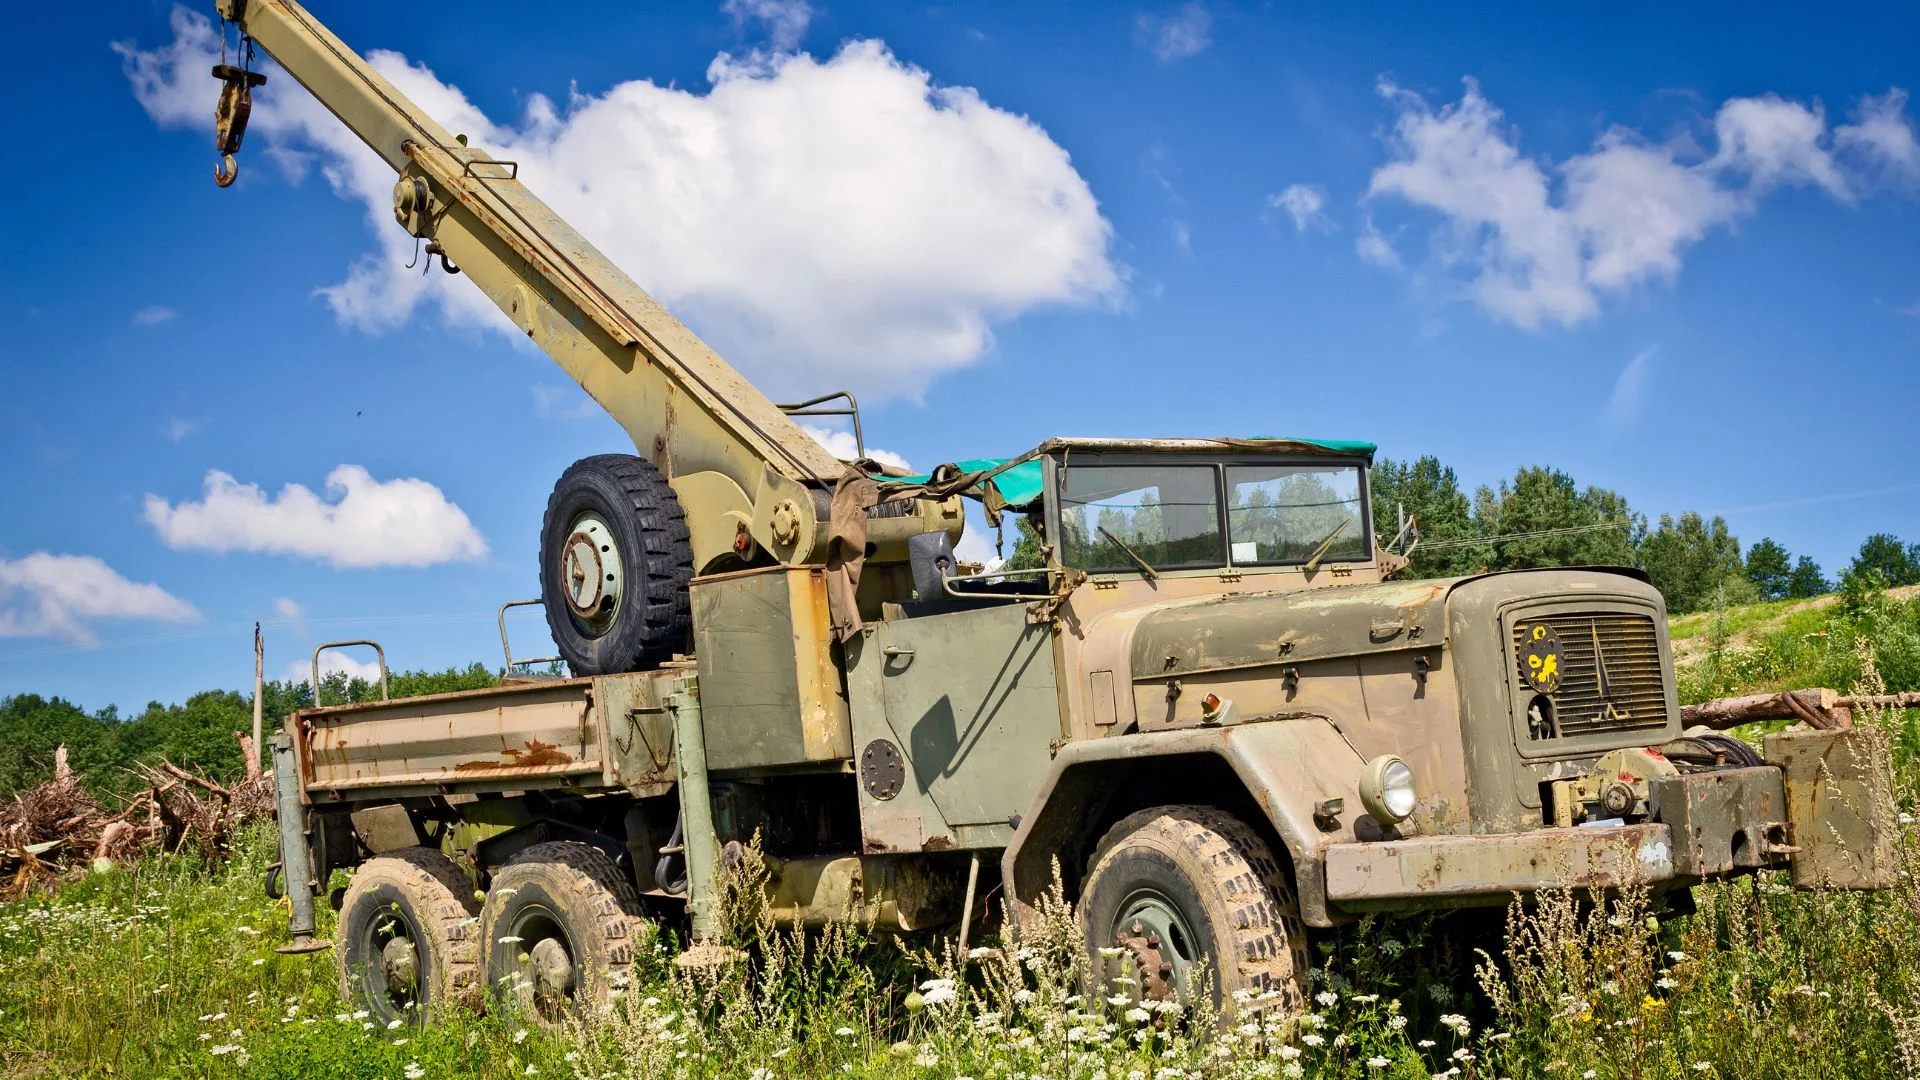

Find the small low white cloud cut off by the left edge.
[{"left": 0, "top": 552, "right": 200, "bottom": 646}]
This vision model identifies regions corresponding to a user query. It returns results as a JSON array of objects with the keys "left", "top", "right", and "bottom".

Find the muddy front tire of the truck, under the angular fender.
[{"left": 1079, "top": 805, "right": 1308, "bottom": 1013}]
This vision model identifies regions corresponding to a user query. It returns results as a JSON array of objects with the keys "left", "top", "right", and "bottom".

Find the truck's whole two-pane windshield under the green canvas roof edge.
[{"left": 1060, "top": 455, "right": 1369, "bottom": 573}]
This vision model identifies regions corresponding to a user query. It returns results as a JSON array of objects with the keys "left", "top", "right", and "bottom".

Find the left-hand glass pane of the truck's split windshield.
[{"left": 1060, "top": 463, "right": 1227, "bottom": 571}]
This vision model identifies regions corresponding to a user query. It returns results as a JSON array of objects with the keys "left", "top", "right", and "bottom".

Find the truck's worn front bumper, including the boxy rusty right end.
[{"left": 1325, "top": 728, "right": 1897, "bottom": 899}]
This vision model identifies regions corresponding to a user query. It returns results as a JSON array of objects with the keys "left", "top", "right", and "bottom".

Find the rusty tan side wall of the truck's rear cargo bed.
[{"left": 288, "top": 667, "right": 695, "bottom": 803}]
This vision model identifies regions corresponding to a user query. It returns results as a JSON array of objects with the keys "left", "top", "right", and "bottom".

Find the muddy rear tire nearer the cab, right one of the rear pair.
[{"left": 480, "top": 840, "right": 639, "bottom": 1024}]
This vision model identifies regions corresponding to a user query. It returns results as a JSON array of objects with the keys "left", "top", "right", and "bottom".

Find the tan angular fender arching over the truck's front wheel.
[{"left": 1000, "top": 717, "right": 1365, "bottom": 926}]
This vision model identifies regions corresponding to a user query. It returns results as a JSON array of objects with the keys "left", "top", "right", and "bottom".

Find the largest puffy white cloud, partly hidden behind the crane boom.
[{"left": 117, "top": 6, "right": 1125, "bottom": 398}]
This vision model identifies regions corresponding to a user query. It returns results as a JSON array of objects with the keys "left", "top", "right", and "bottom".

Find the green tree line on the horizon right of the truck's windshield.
[{"left": 1373, "top": 455, "right": 1920, "bottom": 615}]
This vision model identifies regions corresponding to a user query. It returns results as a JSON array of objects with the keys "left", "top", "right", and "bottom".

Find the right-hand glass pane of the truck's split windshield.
[{"left": 1227, "top": 465, "right": 1367, "bottom": 565}]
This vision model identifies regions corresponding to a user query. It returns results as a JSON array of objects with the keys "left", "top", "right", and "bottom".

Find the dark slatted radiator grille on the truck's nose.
[{"left": 1513, "top": 611, "right": 1667, "bottom": 738}]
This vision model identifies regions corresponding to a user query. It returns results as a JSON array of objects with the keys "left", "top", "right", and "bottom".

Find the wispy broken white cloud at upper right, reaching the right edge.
[{"left": 1359, "top": 79, "right": 1920, "bottom": 329}]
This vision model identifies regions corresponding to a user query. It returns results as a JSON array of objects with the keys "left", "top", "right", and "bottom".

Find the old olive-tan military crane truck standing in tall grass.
[{"left": 202, "top": 0, "right": 1891, "bottom": 1019}]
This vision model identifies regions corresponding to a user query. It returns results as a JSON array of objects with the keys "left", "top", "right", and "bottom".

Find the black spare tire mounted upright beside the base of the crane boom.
[{"left": 540, "top": 454, "right": 693, "bottom": 675}]
